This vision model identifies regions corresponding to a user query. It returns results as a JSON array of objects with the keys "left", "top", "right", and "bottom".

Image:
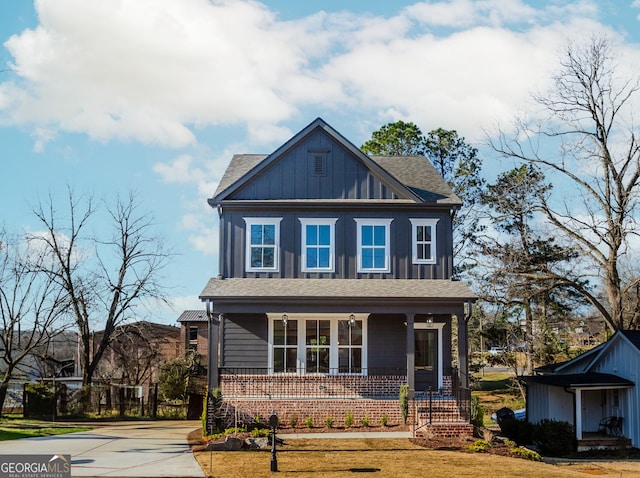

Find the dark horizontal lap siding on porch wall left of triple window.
[{"left": 220, "top": 314, "right": 269, "bottom": 369}]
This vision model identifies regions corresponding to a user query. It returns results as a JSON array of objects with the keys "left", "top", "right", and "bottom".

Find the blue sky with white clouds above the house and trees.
[{"left": 0, "top": 0, "right": 640, "bottom": 323}]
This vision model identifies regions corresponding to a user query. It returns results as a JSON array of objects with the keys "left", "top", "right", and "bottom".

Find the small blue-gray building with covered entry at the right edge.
[{"left": 520, "top": 330, "right": 640, "bottom": 448}]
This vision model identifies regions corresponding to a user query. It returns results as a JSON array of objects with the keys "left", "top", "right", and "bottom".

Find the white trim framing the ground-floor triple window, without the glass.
[{"left": 268, "top": 313, "right": 369, "bottom": 375}]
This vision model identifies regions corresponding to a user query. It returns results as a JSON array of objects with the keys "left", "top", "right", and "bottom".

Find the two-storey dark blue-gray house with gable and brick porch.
[{"left": 200, "top": 118, "right": 476, "bottom": 432}]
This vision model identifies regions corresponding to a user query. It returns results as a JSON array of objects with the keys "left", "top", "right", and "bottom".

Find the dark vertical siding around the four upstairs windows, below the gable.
[{"left": 221, "top": 207, "right": 453, "bottom": 279}]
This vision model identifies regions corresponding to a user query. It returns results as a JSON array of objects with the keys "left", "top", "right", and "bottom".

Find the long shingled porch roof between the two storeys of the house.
[{"left": 200, "top": 278, "right": 477, "bottom": 312}]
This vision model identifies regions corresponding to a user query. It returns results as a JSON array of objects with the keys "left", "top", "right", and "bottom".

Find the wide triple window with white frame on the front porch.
[{"left": 270, "top": 314, "right": 366, "bottom": 375}]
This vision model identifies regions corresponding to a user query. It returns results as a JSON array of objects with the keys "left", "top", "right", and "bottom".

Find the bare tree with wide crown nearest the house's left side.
[{"left": 33, "top": 188, "right": 173, "bottom": 386}]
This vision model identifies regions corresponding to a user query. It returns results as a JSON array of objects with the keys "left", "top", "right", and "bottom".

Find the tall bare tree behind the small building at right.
[{"left": 492, "top": 38, "right": 640, "bottom": 330}]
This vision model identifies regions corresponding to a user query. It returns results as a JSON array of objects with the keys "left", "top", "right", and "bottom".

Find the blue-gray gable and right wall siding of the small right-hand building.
[{"left": 590, "top": 336, "right": 640, "bottom": 447}]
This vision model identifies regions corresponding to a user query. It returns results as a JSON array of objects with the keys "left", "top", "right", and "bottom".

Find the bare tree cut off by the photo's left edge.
[{"left": 0, "top": 232, "right": 68, "bottom": 410}]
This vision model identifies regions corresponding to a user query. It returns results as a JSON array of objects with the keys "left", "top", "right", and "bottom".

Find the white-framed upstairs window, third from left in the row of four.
[{"left": 354, "top": 219, "right": 393, "bottom": 272}]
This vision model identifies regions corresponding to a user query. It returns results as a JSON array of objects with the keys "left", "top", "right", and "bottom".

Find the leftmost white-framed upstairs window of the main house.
[{"left": 244, "top": 217, "right": 282, "bottom": 272}]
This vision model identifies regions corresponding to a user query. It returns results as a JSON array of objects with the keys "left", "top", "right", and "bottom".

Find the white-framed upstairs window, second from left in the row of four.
[{"left": 300, "top": 218, "right": 337, "bottom": 272}]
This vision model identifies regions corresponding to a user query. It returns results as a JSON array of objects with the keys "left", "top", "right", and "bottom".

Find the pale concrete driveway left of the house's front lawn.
[{"left": 0, "top": 420, "right": 204, "bottom": 478}]
